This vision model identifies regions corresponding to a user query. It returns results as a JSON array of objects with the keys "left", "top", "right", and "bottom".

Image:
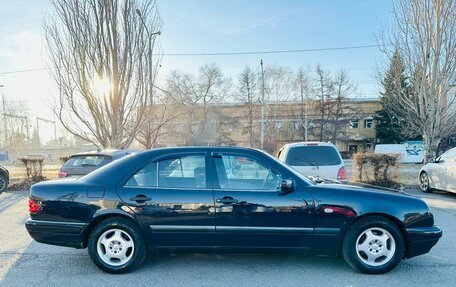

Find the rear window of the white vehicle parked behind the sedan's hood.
[{"left": 285, "top": 146, "right": 341, "bottom": 166}]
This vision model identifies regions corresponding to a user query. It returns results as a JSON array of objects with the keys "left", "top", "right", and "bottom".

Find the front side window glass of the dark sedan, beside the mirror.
[{"left": 215, "top": 155, "right": 281, "bottom": 190}]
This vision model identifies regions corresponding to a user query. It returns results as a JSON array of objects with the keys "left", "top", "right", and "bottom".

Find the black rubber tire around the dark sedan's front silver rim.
[{"left": 342, "top": 216, "right": 405, "bottom": 274}]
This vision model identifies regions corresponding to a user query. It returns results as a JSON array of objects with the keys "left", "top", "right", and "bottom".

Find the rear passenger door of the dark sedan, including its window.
[{"left": 119, "top": 153, "right": 215, "bottom": 247}]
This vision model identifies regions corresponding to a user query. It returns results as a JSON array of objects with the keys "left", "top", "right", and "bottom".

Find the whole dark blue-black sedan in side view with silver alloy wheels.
[{"left": 25, "top": 147, "right": 442, "bottom": 274}]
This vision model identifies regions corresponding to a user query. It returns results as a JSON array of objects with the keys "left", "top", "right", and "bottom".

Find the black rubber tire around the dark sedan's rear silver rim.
[{"left": 88, "top": 217, "right": 147, "bottom": 274}]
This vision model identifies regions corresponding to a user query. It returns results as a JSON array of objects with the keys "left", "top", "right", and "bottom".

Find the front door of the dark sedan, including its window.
[{"left": 212, "top": 153, "right": 314, "bottom": 249}]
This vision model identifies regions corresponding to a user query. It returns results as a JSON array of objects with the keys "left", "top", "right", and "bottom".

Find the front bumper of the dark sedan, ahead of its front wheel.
[{"left": 405, "top": 225, "right": 442, "bottom": 258}]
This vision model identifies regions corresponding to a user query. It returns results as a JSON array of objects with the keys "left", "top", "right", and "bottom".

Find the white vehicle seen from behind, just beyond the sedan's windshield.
[{"left": 278, "top": 142, "right": 347, "bottom": 180}]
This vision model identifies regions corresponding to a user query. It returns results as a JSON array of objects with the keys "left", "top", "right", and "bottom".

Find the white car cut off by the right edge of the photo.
[{"left": 419, "top": 148, "right": 456, "bottom": 192}]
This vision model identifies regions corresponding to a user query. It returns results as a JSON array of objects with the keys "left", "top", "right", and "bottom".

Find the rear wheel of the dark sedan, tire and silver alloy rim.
[{"left": 88, "top": 218, "right": 147, "bottom": 273}]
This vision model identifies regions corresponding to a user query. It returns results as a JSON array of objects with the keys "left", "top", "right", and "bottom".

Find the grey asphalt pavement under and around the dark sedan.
[{"left": 0, "top": 190, "right": 456, "bottom": 287}]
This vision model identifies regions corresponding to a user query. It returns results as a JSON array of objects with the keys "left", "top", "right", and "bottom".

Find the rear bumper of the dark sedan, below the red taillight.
[{"left": 25, "top": 218, "right": 87, "bottom": 248}]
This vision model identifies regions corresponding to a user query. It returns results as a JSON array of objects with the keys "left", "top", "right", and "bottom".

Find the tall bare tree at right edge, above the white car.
[{"left": 386, "top": 0, "right": 456, "bottom": 162}]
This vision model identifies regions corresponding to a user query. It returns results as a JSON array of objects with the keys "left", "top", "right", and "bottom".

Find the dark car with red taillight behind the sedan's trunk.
[{"left": 58, "top": 149, "right": 135, "bottom": 178}]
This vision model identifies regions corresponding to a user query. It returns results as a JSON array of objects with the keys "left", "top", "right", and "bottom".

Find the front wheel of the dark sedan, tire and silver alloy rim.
[{"left": 342, "top": 216, "right": 405, "bottom": 274}]
